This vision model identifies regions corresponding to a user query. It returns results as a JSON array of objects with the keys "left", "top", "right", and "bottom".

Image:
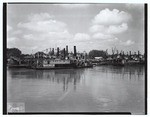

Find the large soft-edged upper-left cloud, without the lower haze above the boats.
[{"left": 18, "top": 13, "right": 72, "bottom": 40}]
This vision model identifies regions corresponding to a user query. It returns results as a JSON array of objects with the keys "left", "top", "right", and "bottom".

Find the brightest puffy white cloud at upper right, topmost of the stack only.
[{"left": 92, "top": 8, "right": 131, "bottom": 25}]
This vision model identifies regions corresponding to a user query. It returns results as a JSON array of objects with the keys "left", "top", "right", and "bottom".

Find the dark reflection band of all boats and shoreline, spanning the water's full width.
[{"left": 9, "top": 66, "right": 145, "bottom": 91}]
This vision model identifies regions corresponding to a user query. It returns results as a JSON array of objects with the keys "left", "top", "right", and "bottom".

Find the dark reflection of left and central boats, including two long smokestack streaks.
[{"left": 9, "top": 69, "right": 85, "bottom": 91}]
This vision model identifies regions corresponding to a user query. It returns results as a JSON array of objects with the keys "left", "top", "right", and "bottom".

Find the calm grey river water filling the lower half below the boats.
[{"left": 7, "top": 66, "right": 145, "bottom": 114}]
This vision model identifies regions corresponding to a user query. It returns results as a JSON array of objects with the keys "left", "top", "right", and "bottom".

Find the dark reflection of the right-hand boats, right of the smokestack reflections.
[{"left": 94, "top": 65, "right": 145, "bottom": 80}]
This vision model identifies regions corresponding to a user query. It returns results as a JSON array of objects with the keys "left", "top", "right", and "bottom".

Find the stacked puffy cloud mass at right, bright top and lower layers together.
[{"left": 89, "top": 8, "right": 133, "bottom": 45}]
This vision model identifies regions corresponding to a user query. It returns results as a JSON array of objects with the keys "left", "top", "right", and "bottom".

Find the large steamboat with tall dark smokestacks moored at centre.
[{"left": 30, "top": 46, "right": 93, "bottom": 69}]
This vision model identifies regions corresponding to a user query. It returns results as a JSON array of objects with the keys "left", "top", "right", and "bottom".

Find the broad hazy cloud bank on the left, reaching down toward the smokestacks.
[{"left": 14, "top": 13, "right": 93, "bottom": 50}]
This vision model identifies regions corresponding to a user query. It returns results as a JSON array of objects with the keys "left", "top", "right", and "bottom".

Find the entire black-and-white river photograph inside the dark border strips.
[{"left": 4, "top": 3, "right": 147, "bottom": 115}]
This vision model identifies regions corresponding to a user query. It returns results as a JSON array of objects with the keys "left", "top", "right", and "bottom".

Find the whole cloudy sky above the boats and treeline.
[{"left": 7, "top": 4, "right": 144, "bottom": 54}]
